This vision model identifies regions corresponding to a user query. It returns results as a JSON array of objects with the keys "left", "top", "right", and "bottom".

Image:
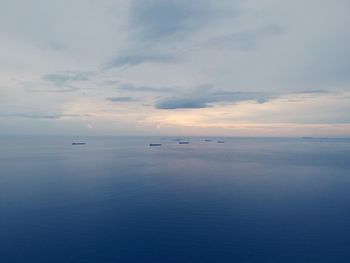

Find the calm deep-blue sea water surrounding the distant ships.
[{"left": 0, "top": 137, "right": 350, "bottom": 263}]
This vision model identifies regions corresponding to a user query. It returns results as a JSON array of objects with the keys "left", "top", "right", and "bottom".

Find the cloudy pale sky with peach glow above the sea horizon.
[{"left": 0, "top": 0, "right": 350, "bottom": 136}]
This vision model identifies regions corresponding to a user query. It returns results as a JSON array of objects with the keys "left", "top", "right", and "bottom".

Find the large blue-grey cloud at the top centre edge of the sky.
[{"left": 106, "top": 0, "right": 227, "bottom": 69}]
